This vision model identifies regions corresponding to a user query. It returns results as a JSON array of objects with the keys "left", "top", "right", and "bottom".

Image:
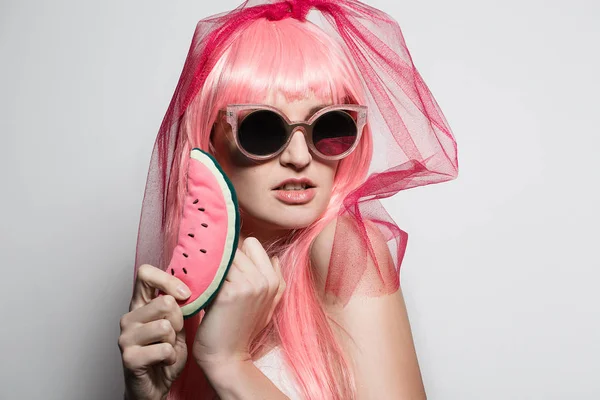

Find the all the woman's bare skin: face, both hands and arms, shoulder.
[{"left": 119, "top": 90, "right": 425, "bottom": 400}]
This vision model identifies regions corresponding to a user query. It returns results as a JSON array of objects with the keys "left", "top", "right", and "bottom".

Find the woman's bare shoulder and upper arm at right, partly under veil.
[{"left": 311, "top": 218, "right": 426, "bottom": 399}]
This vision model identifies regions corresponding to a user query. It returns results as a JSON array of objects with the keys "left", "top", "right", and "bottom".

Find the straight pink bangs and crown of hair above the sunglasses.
[{"left": 213, "top": 18, "right": 349, "bottom": 106}]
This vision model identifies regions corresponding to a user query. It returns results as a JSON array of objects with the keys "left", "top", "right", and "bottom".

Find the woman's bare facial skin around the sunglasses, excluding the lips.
[{"left": 212, "top": 89, "right": 338, "bottom": 243}]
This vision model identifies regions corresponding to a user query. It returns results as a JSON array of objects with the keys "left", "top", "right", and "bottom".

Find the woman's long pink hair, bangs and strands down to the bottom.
[{"left": 165, "top": 18, "right": 372, "bottom": 400}]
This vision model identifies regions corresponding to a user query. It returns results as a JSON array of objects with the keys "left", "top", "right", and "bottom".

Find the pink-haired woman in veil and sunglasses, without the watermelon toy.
[{"left": 119, "top": 0, "right": 458, "bottom": 399}]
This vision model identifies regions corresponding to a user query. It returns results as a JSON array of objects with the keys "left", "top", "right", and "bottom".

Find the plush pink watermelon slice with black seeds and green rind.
[{"left": 166, "top": 148, "right": 240, "bottom": 318}]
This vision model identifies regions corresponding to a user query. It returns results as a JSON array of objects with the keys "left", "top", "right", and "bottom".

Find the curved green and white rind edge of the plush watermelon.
[{"left": 181, "top": 147, "right": 240, "bottom": 319}]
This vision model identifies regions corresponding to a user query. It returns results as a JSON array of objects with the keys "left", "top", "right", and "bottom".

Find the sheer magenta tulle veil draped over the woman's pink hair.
[{"left": 134, "top": 0, "right": 458, "bottom": 303}]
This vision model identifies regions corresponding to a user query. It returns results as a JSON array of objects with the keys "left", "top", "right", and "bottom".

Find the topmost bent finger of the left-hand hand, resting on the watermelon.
[{"left": 129, "top": 264, "right": 190, "bottom": 311}]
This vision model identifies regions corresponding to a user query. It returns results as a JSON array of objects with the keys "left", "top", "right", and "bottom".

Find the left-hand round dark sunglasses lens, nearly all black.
[{"left": 238, "top": 110, "right": 287, "bottom": 156}]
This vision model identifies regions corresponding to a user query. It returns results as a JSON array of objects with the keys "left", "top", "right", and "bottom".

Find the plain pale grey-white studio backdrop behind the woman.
[{"left": 0, "top": 0, "right": 600, "bottom": 400}]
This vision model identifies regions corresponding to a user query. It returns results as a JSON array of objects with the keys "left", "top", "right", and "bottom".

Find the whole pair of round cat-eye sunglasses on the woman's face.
[{"left": 220, "top": 104, "right": 367, "bottom": 161}]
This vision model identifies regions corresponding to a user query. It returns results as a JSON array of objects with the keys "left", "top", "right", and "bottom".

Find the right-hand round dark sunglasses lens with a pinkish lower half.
[{"left": 313, "top": 110, "right": 358, "bottom": 156}]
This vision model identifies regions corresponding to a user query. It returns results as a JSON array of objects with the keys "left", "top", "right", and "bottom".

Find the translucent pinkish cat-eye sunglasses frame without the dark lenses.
[{"left": 219, "top": 104, "right": 367, "bottom": 161}]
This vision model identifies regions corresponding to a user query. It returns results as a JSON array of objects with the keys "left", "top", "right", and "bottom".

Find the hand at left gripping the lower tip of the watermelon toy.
[{"left": 119, "top": 264, "right": 190, "bottom": 400}]
